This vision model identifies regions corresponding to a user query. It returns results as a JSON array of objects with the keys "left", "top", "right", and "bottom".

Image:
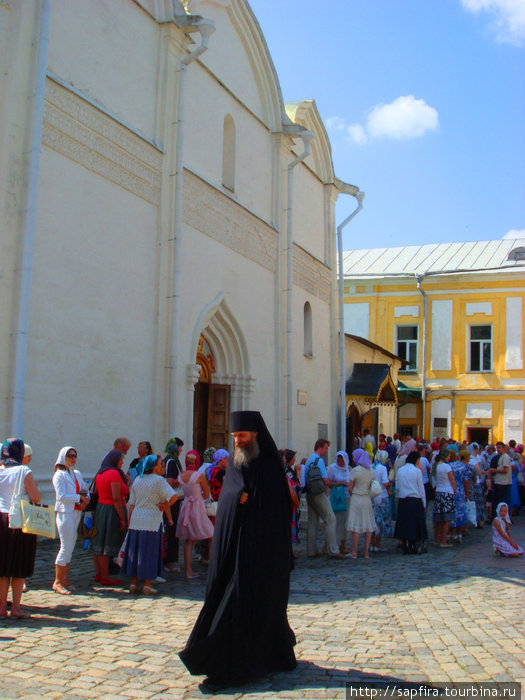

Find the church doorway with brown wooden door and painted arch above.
[{"left": 193, "top": 334, "right": 227, "bottom": 455}]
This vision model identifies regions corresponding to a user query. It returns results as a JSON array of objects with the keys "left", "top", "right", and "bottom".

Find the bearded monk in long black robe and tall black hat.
[{"left": 179, "top": 411, "right": 297, "bottom": 691}]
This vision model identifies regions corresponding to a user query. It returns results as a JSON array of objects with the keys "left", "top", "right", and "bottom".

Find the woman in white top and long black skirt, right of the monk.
[{"left": 394, "top": 450, "right": 427, "bottom": 554}]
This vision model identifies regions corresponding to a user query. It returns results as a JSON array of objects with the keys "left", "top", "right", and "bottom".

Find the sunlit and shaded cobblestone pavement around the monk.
[{"left": 0, "top": 515, "right": 525, "bottom": 700}]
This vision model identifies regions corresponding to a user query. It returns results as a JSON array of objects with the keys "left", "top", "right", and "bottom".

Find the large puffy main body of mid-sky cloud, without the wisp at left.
[{"left": 366, "top": 95, "right": 439, "bottom": 140}]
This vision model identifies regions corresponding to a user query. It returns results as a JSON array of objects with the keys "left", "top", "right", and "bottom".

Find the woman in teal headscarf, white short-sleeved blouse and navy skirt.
[{"left": 121, "top": 454, "right": 177, "bottom": 595}]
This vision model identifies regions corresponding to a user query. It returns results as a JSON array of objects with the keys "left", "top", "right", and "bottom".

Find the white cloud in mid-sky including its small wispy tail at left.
[{"left": 326, "top": 95, "right": 439, "bottom": 145}]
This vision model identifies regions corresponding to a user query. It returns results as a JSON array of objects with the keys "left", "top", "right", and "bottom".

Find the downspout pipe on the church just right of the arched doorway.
[{"left": 285, "top": 129, "right": 314, "bottom": 449}]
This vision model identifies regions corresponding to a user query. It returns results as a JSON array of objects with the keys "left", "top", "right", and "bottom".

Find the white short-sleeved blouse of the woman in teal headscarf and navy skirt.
[{"left": 128, "top": 474, "right": 175, "bottom": 532}]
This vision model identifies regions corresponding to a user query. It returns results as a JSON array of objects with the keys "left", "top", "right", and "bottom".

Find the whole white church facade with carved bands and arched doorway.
[{"left": 0, "top": 0, "right": 358, "bottom": 488}]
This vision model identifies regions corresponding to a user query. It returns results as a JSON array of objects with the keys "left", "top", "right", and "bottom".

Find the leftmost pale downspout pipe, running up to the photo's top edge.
[{"left": 11, "top": 0, "right": 51, "bottom": 435}]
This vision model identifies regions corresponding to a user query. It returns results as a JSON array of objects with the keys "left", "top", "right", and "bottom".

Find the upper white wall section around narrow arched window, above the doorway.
[{"left": 184, "top": 64, "right": 272, "bottom": 220}]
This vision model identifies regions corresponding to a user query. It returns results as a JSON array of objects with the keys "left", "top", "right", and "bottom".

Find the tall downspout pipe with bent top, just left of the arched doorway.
[{"left": 168, "top": 15, "right": 215, "bottom": 439}]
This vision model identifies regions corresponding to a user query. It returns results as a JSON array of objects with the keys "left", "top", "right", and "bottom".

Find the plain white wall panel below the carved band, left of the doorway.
[{"left": 24, "top": 148, "right": 161, "bottom": 486}]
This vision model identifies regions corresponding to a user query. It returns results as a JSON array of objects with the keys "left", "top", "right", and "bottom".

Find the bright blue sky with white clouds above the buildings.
[{"left": 250, "top": 0, "right": 525, "bottom": 249}]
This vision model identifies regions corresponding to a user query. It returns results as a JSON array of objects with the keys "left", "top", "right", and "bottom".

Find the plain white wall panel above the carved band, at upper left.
[{"left": 48, "top": 0, "right": 160, "bottom": 140}]
